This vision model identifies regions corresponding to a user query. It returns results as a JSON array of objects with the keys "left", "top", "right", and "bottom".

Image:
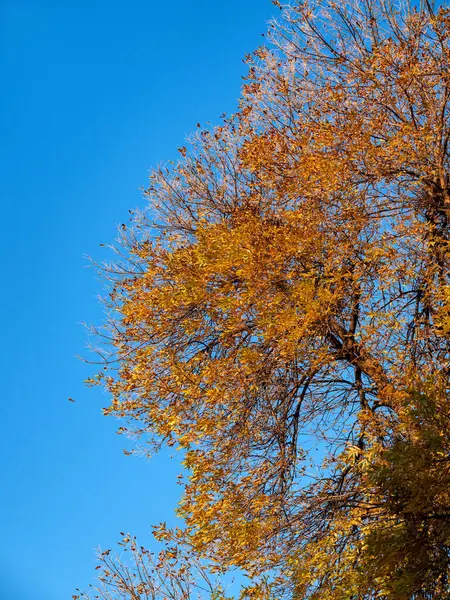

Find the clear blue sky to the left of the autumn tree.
[{"left": 0, "top": 0, "right": 275, "bottom": 600}]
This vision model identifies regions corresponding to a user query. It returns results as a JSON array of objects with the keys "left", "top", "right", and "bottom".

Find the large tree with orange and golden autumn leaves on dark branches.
[{"left": 87, "top": 0, "right": 450, "bottom": 600}]
